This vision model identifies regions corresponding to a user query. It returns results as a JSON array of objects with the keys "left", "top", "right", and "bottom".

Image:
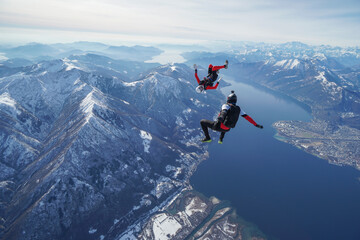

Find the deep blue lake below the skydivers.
[{"left": 190, "top": 79, "right": 360, "bottom": 240}]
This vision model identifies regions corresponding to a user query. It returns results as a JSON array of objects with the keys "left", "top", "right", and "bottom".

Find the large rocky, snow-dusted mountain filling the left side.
[{"left": 0, "top": 55, "right": 223, "bottom": 239}]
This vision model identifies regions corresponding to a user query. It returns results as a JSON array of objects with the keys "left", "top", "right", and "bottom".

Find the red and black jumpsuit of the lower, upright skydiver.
[{"left": 200, "top": 103, "right": 257, "bottom": 141}]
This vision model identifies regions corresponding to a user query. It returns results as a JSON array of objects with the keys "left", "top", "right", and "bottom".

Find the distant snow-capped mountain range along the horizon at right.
[{"left": 182, "top": 42, "right": 360, "bottom": 67}]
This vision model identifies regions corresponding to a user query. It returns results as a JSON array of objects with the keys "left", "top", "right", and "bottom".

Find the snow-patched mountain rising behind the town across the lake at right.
[{"left": 229, "top": 54, "right": 360, "bottom": 128}]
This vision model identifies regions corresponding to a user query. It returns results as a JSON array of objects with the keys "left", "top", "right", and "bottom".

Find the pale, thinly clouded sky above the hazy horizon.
[{"left": 0, "top": 0, "right": 360, "bottom": 46}]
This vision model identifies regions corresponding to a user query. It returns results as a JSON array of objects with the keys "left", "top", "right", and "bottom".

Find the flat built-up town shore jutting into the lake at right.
[{"left": 272, "top": 119, "right": 360, "bottom": 170}]
